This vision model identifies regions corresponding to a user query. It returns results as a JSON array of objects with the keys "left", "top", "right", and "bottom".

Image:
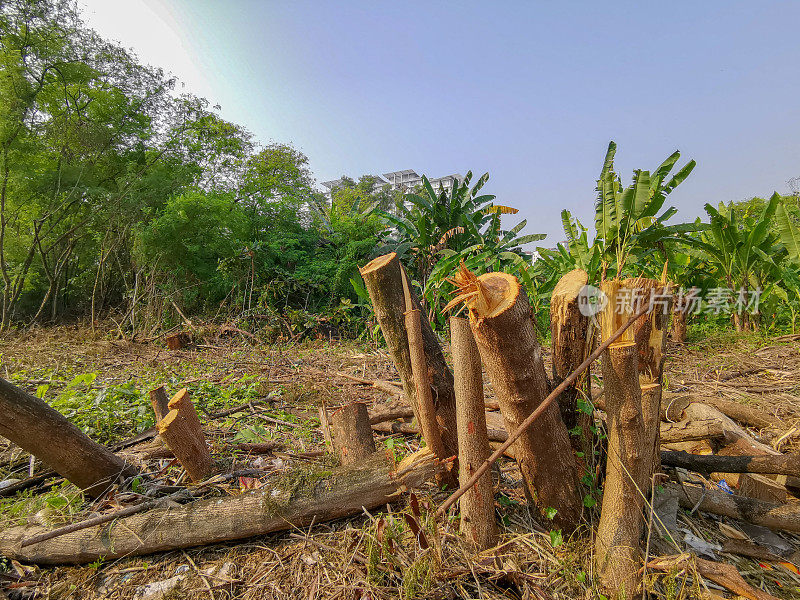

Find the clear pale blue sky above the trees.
[{"left": 80, "top": 0, "right": 800, "bottom": 246}]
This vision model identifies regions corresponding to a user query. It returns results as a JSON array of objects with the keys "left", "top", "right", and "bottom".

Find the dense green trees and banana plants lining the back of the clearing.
[{"left": 0, "top": 0, "right": 800, "bottom": 336}]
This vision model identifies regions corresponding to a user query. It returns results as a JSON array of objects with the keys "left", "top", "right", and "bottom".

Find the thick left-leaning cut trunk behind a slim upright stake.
[{"left": 360, "top": 252, "right": 458, "bottom": 456}]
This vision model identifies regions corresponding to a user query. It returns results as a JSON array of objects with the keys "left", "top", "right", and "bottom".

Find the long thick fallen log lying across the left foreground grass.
[{"left": 0, "top": 451, "right": 443, "bottom": 564}]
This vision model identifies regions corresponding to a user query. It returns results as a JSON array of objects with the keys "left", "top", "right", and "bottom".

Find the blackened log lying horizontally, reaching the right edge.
[{"left": 661, "top": 450, "right": 800, "bottom": 475}]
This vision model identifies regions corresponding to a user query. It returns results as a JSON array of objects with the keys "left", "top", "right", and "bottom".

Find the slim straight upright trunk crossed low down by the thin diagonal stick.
[{"left": 450, "top": 317, "right": 497, "bottom": 550}]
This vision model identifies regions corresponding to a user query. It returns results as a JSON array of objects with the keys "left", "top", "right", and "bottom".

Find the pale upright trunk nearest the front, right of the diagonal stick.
[{"left": 595, "top": 340, "right": 652, "bottom": 598}]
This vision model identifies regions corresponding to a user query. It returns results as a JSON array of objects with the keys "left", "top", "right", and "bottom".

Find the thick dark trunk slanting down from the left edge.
[{"left": 0, "top": 379, "right": 136, "bottom": 497}]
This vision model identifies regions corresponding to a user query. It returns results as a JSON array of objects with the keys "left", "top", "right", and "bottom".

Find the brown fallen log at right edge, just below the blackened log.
[{"left": 664, "top": 483, "right": 800, "bottom": 533}]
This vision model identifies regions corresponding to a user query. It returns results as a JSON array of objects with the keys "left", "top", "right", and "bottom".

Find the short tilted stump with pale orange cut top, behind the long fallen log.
[{"left": 157, "top": 388, "right": 214, "bottom": 481}]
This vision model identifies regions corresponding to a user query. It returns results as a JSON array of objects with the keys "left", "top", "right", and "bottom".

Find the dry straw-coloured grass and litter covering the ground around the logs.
[{"left": 0, "top": 327, "right": 800, "bottom": 600}]
